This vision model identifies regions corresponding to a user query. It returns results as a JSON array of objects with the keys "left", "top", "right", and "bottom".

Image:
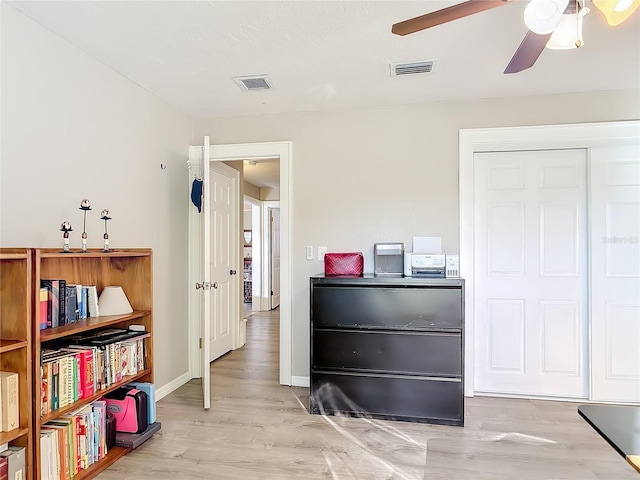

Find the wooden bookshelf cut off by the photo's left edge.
[{"left": 0, "top": 248, "right": 34, "bottom": 479}]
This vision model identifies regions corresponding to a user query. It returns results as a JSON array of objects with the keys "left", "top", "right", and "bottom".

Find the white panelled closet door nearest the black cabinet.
[{"left": 474, "top": 149, "right": 588, "bottom": 398}]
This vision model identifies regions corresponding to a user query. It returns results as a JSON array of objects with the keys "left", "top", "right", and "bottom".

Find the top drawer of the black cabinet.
[{"left": 311, "top": 285, "right": 462, "bottom": 330}]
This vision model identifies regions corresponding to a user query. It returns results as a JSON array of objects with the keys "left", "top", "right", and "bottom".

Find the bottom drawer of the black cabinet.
[{"left": 309, "top": 372, "right": 464, "bottom": 425}]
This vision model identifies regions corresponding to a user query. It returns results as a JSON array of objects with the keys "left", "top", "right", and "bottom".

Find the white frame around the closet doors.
[{"left": 458, "top": 121, "right": 640, "bottom": 396}]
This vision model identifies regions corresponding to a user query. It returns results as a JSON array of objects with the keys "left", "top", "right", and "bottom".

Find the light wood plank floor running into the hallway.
[{"left": 98, "top": 312, "right": 640, "bottom": 480}]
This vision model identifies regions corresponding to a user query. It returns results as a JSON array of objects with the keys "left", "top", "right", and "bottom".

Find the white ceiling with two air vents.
[{"left": 10, "top": 0, "right": 640, "bottom": 118}]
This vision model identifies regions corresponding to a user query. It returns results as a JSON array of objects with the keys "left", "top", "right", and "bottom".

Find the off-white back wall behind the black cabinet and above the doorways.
[{"left": 195, "top": 87, "right": 640, "bottom": 376}]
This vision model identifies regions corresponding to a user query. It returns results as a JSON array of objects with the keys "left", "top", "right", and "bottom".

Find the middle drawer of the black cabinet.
[{"left": 312, "top": 330, "right": 462, "bottom": 376}]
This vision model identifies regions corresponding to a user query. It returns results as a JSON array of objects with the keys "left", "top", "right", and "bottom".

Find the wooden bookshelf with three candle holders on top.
[{"left": 31, "top": 248, "right": 153, "bottom": 480}]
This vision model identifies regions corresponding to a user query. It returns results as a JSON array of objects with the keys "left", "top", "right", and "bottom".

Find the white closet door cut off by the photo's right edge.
[{"left": 590, "top": 142, "right": 640, "bottom": 402}]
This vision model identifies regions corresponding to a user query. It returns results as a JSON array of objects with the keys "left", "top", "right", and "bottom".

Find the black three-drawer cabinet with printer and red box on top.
[{"left": 309, "top": 274, "right": 464, "bottom": 425}]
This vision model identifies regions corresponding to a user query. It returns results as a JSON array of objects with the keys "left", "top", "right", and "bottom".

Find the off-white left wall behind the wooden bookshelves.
[{"left": 0, "top": 2, "right": 193, "bottom": 387}]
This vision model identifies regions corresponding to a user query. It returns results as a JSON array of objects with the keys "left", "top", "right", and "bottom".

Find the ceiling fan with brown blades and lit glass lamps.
[{"left": 391, "top": 0, "right": 640, "bottom": 73}]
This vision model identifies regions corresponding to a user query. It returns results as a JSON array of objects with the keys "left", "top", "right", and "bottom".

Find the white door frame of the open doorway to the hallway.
[{"left": 189, "top": 142, "right": 293, "bottom": 386}]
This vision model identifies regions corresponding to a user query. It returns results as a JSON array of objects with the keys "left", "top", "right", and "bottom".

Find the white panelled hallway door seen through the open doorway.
[{"left": 205, "top": 161, "right": 240, "bottom": 362}]
